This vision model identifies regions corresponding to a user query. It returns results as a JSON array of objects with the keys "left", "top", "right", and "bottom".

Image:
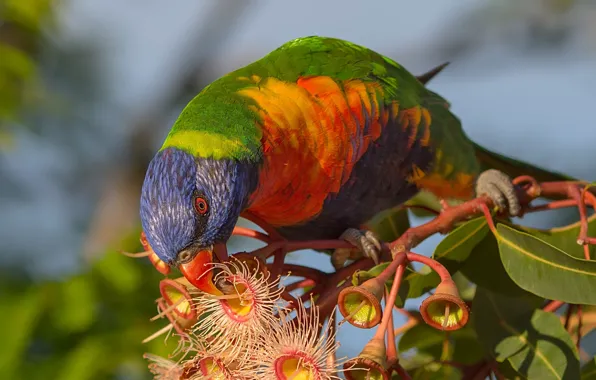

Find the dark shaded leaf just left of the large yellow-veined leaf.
[{"left": 460, "top": 234, "right": 525, "bottom": 296}]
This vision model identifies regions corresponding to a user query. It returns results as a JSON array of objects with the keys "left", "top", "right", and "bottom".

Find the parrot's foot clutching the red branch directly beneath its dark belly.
[{"left": 331, "top": 228, "right": 382, "bottom": 270}]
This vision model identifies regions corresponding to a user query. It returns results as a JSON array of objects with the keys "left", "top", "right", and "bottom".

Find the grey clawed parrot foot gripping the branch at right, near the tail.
[{"left": 476, "top": 169, "right": 521, "bottom": 216}]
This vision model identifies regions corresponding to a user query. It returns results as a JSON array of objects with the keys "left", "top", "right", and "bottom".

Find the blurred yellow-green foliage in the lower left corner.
[{"left": 0, "top": 232, "right": 170, "bottom": 380}]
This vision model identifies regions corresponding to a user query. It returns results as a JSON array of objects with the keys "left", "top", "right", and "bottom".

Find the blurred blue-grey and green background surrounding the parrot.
[{"left": 0, "top": 0, "right": 596, "bottom": 379}]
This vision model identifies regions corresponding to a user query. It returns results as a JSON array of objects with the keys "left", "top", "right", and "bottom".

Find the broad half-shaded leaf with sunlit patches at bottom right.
[{"left": 472, "top": 289, "right": 579, "bottom": 379}]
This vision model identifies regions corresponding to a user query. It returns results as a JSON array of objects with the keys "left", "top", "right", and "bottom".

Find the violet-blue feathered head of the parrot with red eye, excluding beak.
[{"left": 140, "top": 148, "right": 258, "bottom": 280}]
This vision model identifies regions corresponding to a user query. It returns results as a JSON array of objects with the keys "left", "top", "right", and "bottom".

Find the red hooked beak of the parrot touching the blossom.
[{"left": 178, "top": 244, "right": 227, "bottom": 295}]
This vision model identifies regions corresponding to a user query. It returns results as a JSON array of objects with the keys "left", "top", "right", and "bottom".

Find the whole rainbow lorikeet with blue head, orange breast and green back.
[{"left": 140, "top": 36, "right": 568, "bottom": 290}]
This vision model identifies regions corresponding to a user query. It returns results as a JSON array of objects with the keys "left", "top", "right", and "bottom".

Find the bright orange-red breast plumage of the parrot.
[{"left": 240, "top": 76, "right": 400, "bottom": 226}]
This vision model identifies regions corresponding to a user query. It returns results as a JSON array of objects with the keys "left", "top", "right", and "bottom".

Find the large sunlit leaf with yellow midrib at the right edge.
[{"left": 497, "top": 224, "right": 596, "bottom": 305}]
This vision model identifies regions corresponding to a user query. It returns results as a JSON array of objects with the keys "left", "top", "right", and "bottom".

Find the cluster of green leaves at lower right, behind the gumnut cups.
[{"left": 368, "top": 202, "right": 596, "bottom": 379}]
